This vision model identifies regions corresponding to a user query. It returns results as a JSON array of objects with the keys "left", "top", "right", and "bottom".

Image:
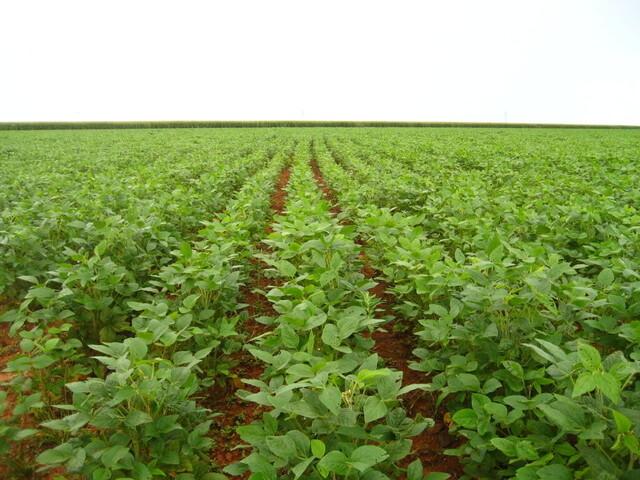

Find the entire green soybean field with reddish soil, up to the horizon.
[{"left": 0, "top": 126, "right": 640, "bottom": 480}]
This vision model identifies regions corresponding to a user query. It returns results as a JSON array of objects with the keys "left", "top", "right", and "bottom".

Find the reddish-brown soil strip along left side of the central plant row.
[{"left": 208, "top": 166, "right": 291, "bottom": 472}]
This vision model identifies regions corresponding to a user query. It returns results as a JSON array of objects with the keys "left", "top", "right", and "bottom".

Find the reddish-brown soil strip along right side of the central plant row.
[{"left": 310, "top": 148, "right": 463, "bottom": 479}]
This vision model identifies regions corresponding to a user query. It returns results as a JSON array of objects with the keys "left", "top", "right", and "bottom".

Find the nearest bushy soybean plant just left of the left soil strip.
[{"left": 37, "top": 336, "right": 225, "bottom": 480}]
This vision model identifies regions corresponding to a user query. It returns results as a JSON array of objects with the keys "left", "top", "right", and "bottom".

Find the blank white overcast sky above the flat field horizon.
[{"left": 0, "top": 0, "right": 640, "bottom": 125}]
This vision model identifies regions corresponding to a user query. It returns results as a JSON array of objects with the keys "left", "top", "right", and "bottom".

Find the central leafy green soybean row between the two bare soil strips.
[{"left": 225, "top": 142, "right": 448, "bottom": 480}]
